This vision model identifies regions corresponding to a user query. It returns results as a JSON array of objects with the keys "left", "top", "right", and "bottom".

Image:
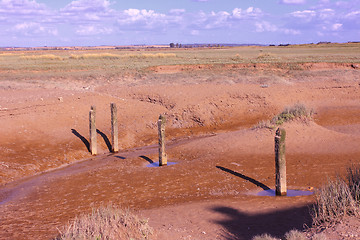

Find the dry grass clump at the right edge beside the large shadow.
[{"left": 311, "top": 165, "right": 360, "bottom": 228}]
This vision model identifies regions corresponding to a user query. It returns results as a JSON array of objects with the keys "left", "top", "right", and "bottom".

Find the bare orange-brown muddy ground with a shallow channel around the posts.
[{"left": 0, "top": 63, "right": 360, "bottom": 239}]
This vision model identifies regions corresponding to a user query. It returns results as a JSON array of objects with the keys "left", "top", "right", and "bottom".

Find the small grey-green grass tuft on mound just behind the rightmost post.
[{"left": 253, "top": 103, "right": 314, "bottom": 129}]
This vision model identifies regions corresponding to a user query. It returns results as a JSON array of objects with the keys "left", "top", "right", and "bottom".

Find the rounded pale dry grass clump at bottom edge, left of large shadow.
[{"left": 55, "top": 205, "right": 152, "bottom": 240}]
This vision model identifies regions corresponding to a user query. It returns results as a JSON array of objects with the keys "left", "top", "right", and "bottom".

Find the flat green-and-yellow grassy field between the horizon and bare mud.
[{"left": 0, "top": 43, "right": 360, "bottom": 81}]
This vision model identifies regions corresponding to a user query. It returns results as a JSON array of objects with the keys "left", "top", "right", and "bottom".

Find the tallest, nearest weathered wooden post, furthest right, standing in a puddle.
[{"left": 275, "top": 128, "right": 287, "bottom": 196}]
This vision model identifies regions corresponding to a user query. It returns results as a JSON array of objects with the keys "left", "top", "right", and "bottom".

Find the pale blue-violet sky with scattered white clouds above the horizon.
[{"left": 0, "top": 0, "right": 360, "bottom": 47}]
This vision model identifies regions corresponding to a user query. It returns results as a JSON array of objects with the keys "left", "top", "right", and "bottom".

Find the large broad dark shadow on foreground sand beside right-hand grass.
[{"left": 211, "top": 205, "right": 312, "bottom": 240}]
